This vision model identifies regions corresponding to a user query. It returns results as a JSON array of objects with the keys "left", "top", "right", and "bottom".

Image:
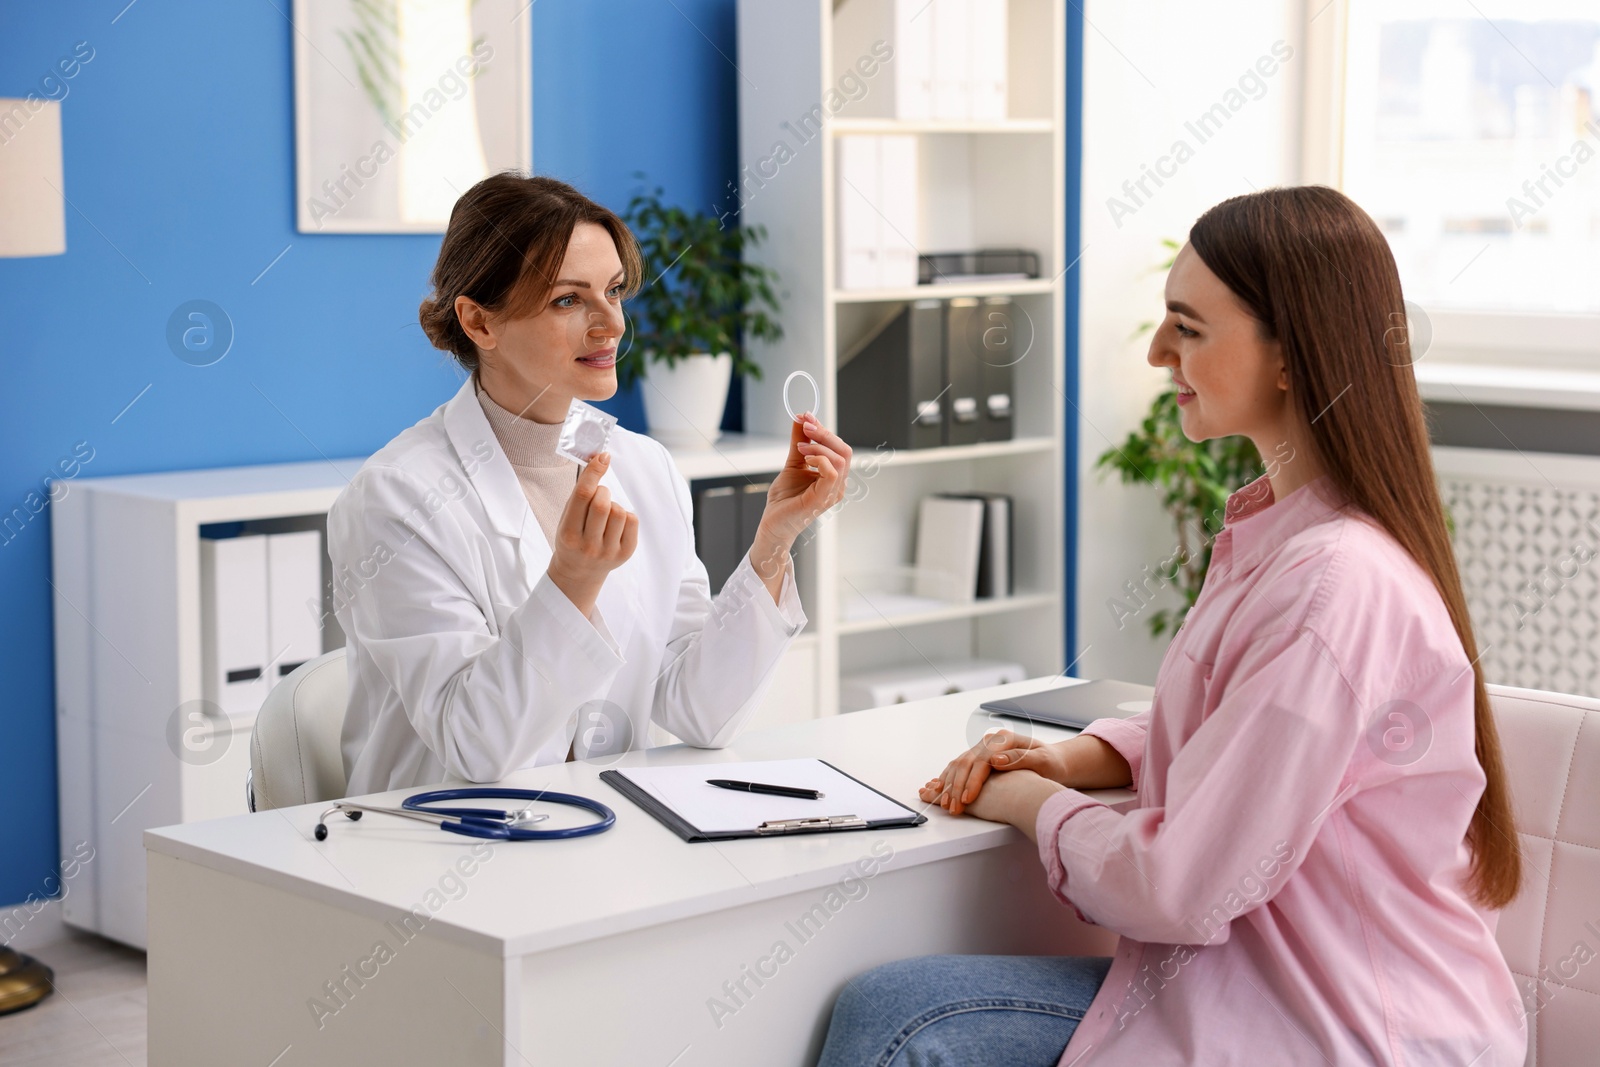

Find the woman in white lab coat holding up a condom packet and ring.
[{"left": 328, "top": 173, "right": 851, "bottom": 795}]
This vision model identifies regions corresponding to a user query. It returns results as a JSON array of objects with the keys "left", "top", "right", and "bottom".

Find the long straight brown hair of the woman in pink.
[{"left": 1189, "top": 186, "right": 1522, "bottom": 909}]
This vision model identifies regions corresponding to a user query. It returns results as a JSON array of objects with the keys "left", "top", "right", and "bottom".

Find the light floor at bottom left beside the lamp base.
[{"left": 0, "top": 931, "right": 146, "bottom": 1067}]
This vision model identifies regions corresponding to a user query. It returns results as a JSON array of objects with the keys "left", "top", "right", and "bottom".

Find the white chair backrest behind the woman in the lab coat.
[{"left": 245, "top": 648, "right": 349, "bottom": 811}]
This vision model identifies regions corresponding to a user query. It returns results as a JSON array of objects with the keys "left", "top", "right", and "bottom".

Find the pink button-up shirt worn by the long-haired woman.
[{"left": 1037, "top": 477, "right": 1528, "bottom": 1067}]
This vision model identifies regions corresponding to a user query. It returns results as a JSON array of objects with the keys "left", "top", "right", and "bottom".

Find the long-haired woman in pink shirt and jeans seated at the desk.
[{"left": 821, "top": 187, "right": 1526, "bottom": 1067}]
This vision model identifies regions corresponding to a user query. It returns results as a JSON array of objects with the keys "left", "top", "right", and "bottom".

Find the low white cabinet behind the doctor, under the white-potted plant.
[{"left": 51, "top": 434, "right": 818, "bottom": 949}]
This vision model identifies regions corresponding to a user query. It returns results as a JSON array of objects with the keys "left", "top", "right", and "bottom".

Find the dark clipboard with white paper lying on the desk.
[{"left": 600, "top": 758, "right": 928, "bottom": 843}]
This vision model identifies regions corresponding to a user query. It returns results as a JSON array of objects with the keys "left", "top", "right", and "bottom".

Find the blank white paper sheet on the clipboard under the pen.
[{"left": 618, "top": 760, "right": 914, "bottom": 833}]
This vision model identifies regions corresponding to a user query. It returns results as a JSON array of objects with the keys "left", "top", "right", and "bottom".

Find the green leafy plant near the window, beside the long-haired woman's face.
[{"left": 1094, "top": 240, "right": 1262, "bottom": 637}]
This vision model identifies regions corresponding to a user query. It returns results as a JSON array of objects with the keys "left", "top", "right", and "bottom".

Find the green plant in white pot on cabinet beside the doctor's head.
[{"left": 616, "top": 189, "right": 782, "bottom": 445}]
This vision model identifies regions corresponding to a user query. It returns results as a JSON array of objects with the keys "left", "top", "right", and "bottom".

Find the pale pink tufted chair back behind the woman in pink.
[{"left": 1488, "top": 685, "right": 1600, "bottom": 1067}]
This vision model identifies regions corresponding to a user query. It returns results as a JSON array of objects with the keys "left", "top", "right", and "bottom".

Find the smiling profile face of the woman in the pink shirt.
[{"left": 1147, "top": 245, "right": 1293, "bottom": 454}]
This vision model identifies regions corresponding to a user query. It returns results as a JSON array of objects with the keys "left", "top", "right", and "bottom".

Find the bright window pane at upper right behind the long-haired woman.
[{"left": 1338, "top": 0, "right": 1600, "bottom": 315}]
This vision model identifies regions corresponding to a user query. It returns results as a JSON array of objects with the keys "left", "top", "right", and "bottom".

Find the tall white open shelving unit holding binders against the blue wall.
[{"left": 738, "top": 0, "right": 1069, "bottom": 715}]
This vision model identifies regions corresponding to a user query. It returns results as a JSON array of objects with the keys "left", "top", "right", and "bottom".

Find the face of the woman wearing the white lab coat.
[{"left": 480, "top": 222, "right": 626, "bottom": 422}]
